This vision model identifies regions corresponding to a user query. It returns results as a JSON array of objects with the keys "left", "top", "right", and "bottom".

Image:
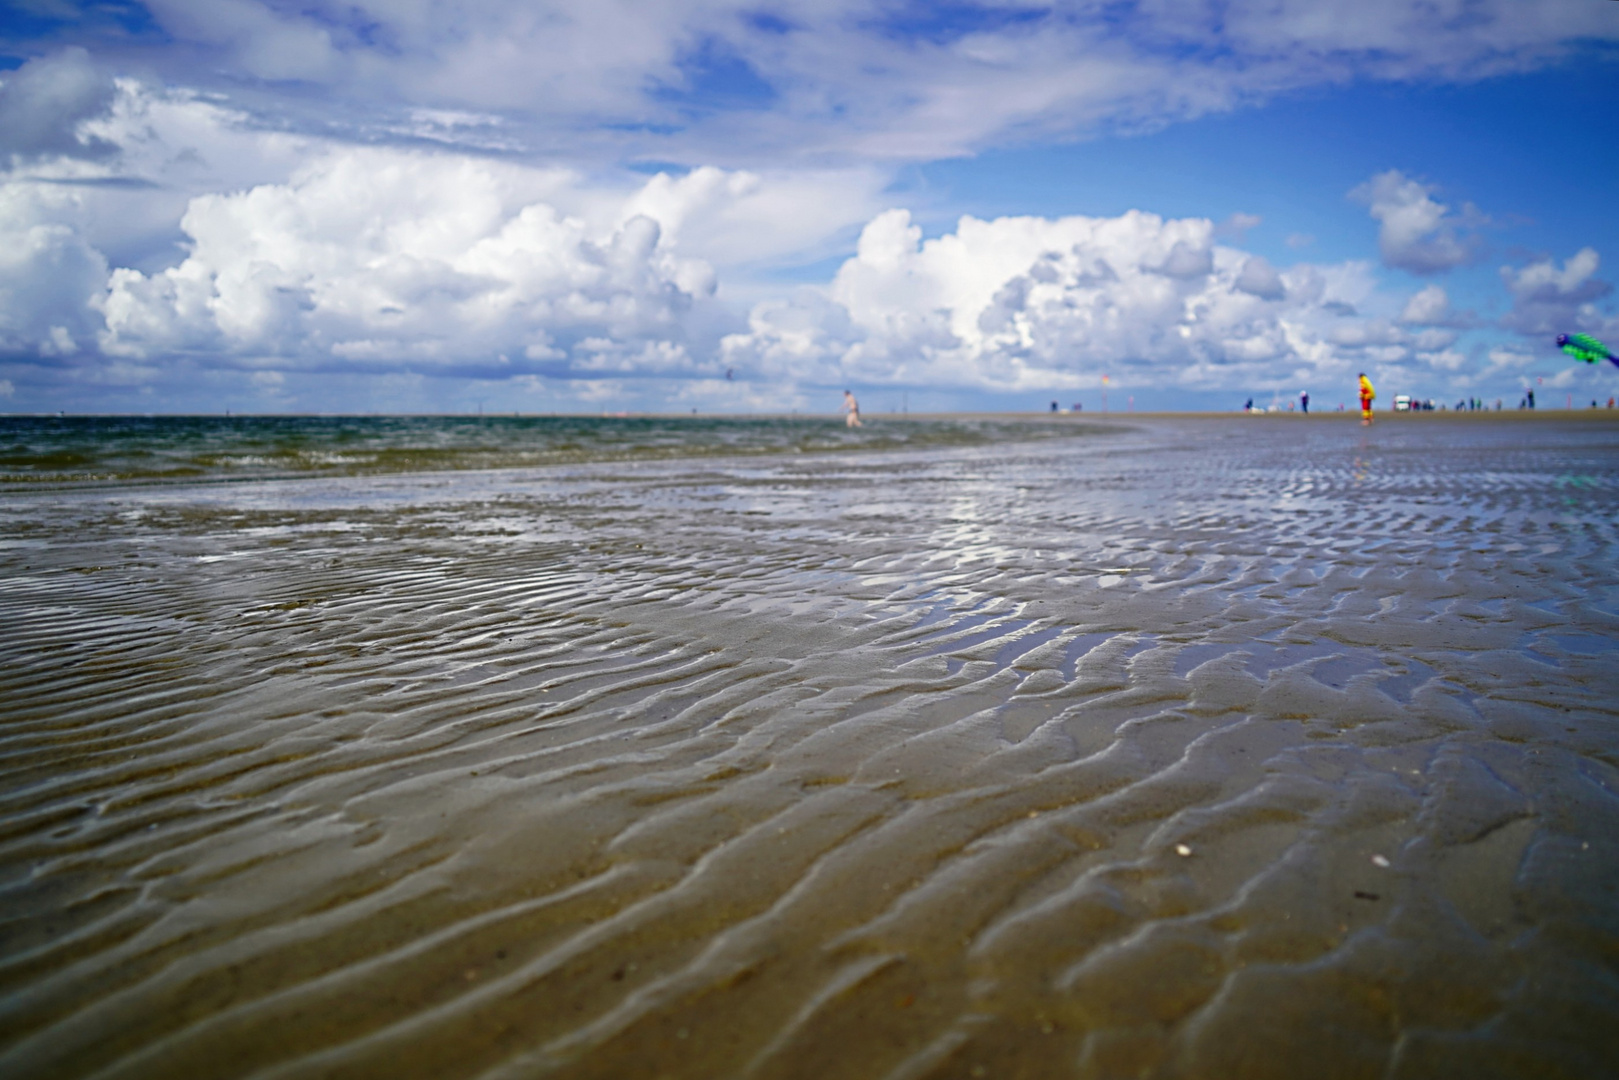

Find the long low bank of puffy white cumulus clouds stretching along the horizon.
[{"left": 0, "top": 131, "right": 1611, "bottom": 405}]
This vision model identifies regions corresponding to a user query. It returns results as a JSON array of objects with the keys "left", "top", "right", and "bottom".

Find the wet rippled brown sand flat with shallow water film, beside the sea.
[{"left": 0, "top": 416, "right": 1619, "bottom": 1080}]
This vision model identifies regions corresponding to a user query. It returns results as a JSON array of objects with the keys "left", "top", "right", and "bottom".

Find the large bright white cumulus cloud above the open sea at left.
[{"left": 88, "top": 151, "right": 714, "bottom": 369}]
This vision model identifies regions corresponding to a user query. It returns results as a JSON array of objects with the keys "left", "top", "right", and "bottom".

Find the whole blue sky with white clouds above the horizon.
[{"left": 0, "top": 0, "right": 1619, "bottom": 413}]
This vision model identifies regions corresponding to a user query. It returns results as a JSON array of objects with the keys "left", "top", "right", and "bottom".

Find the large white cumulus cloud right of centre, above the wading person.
[{"left": 722, "top": 209, "right": 1392, "bottom": 390}]
